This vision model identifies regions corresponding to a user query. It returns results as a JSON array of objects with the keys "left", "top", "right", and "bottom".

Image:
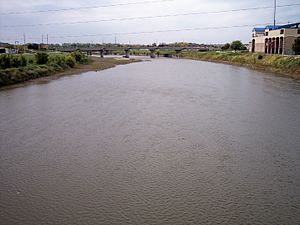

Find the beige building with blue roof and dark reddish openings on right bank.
[{"left": 249, "top": 23, "right": 300, "bottom": 55}]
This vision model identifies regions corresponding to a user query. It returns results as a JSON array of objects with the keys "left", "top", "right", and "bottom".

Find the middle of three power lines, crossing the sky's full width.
[{"left": 0, "top": 3, "right": 300, "bottom": 28}]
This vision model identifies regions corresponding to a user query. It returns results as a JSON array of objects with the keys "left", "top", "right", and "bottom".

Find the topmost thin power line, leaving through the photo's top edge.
[{"left": 0, "top": 0, "right": 176, "bottom": 16}]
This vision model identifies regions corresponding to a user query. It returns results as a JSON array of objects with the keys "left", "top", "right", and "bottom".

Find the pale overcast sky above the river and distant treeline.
[{"left": 0, "top": 0, "right": 300, "bottom": 44}]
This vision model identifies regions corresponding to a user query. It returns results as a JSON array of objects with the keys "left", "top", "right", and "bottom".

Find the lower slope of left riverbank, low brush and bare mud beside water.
[{"left": 0, "top": 57, "right": 140, "bottom": 90}]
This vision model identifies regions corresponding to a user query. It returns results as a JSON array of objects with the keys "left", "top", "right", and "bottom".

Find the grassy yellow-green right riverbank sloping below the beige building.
[{"left": 180, "top": 52, "right": 300, "bottom": 80}]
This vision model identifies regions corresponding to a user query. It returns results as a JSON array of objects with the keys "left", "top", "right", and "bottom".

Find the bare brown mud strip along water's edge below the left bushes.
[{"left": 0, "top": 56, "right": 142, "bottom": 91}]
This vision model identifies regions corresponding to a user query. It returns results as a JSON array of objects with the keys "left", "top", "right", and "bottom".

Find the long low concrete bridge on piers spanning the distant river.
[{"left": 56, "top": 46, "right": 209, "bottom": 58}]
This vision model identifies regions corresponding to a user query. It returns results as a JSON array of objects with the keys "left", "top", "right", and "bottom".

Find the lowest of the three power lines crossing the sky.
[{"left": 1, "top": 23, "right": 290, "bottom": 39}]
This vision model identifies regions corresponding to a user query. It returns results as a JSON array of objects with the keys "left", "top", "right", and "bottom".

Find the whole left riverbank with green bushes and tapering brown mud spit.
[{"left": 0, "top": 54, "right": 138, "bottom": 87}]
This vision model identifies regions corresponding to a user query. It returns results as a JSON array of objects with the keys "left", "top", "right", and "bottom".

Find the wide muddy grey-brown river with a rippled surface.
[{"left": 0, "top": 59, "right": 300, "bottom": 225}]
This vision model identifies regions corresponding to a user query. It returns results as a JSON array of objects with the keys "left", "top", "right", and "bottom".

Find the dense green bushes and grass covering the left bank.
[{"left": 0, "top": 52, "right": 88, "bottom": 87}]
